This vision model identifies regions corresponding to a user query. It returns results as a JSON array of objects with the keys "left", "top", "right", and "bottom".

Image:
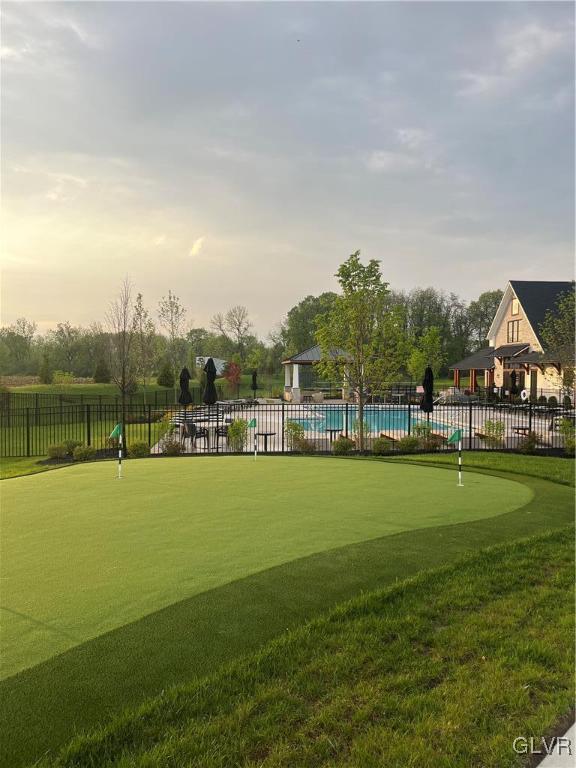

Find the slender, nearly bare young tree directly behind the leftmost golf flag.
[{"left": 106, "top": 278, "right": 135, "bottom": 451}]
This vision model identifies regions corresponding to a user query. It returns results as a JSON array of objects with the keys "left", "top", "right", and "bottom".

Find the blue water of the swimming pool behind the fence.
[{"left": 290, "top": 405, "right": 451, "bottom": 432}]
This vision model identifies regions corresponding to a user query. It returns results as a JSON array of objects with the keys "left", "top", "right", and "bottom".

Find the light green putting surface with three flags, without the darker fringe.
[{"left": 2, "top": 457, "right": 532, "bottom": 677}]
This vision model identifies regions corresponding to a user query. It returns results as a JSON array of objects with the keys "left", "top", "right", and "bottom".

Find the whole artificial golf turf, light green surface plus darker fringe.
[{"left": 0, "top": 457, "right": 572, "bottom": 768}]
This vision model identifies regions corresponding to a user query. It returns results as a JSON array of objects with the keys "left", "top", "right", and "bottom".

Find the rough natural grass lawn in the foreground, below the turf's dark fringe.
[{"left": 41, "top": 530, "right": 574, "bottom": 768}]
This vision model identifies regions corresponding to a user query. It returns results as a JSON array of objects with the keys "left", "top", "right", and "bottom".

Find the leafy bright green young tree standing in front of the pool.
[{"left": 316, "top": 251, "right": 406, "bottom": 451}]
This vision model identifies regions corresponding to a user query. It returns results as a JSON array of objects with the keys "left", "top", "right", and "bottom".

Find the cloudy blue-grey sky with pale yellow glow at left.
[{"left": 0, "top": 2, "right": 574, "bottom": 337}]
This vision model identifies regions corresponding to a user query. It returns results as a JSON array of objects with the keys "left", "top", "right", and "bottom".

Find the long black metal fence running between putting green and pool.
[{"left": 0, "top": 398, "right": 575, "bottom": 457}]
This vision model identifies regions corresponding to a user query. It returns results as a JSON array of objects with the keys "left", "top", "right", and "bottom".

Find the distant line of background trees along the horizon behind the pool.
[{"left": 0, "top": 280, "right": 502, "bottom": 391}]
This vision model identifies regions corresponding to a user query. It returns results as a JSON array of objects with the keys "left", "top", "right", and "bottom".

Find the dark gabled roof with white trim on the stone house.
[{"left": 488, "top": 280, "right": 574, "bottom": 346}]
